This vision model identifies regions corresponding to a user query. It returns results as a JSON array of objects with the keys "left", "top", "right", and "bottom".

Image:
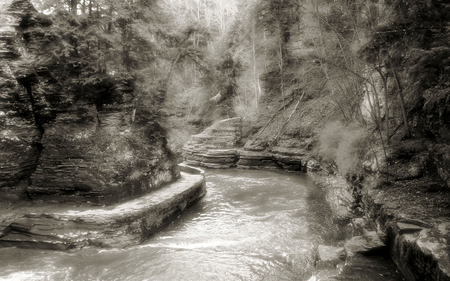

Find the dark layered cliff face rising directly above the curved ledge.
[{"left": 0, "top": 0, "right": 179, "bottom": 204}]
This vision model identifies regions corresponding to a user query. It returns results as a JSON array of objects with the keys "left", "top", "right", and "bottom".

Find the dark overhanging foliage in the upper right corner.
[{"left": 359, "top": 0, "right": 450, "bottom": 140}]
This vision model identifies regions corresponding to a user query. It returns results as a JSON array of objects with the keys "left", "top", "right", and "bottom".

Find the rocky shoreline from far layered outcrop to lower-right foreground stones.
[{"left": 184, "top": 118, "right": 450, "bottom": 281}]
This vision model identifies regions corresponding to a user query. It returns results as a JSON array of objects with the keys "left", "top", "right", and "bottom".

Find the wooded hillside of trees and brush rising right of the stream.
[{"left": 164, "top": 0, "right": 450, "bottom": 186}]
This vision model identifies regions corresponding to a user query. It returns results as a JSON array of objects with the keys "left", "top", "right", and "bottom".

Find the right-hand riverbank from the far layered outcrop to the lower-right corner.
[{"left": 184, "top": 118, "right": 450, "bottom": 280}]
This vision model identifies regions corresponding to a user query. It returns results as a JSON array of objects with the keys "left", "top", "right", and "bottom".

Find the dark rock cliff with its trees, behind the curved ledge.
[{"left": 0, "top": 1, "right": 206, "bottom": 203}]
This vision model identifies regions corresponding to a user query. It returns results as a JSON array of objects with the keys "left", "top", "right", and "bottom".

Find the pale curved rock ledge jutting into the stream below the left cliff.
[{"left": 0, "top": 166, "right": 206, "bottom": 250}]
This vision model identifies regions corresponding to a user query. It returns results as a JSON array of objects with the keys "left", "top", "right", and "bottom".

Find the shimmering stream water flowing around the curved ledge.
[{"left": 0, "top": 167, "right": 400, "bottom": 281}]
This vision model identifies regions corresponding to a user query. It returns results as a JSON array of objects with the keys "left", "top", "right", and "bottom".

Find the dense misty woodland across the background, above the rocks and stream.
[{"left": 25, "top": 0, "right": 450, "bottom": 177}]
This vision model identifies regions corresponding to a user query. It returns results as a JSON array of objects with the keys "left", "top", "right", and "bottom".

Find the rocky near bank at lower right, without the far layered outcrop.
[{"left": 309, "top": 165, "right": 450, "bottom": 281}]
